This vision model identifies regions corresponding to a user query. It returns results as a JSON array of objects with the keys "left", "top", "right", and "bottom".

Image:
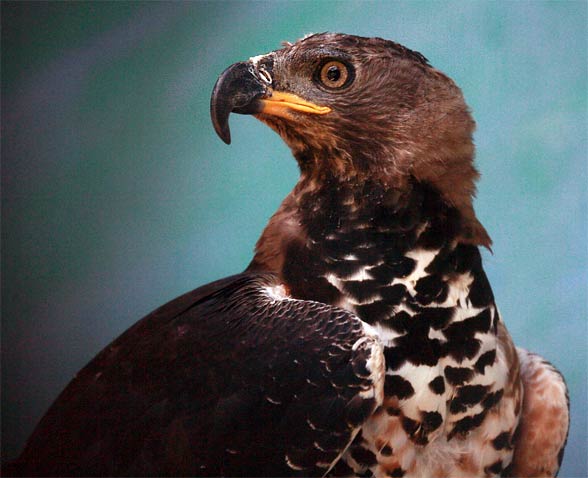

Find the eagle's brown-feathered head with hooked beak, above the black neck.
[{"left": 211, "top": 33, "right": 490, "bottom": 246}]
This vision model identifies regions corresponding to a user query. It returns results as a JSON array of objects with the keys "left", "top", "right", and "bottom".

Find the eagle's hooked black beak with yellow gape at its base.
[{"left": 210, "top": 62, "right": 331, "bottom": 144}]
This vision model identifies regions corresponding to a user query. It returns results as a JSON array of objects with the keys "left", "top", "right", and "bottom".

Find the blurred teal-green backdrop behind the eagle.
[{"left": 1, "top": 1, "right": 588, "bottom": 477}]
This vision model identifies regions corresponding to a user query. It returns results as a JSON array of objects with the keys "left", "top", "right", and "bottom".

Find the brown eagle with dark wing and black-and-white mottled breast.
[{"left": 5, "top": 33, "right": 569, "bottom": 477}]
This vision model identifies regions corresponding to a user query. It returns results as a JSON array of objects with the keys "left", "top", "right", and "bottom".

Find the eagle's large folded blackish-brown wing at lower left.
[{"left": 10, "top": 273, "right": 384, "bottom": 476}]
